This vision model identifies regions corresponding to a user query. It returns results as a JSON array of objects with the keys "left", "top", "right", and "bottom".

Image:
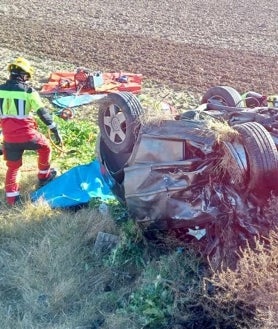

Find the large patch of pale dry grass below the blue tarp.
[{"left": 0, "top": 204, "right": 122, "bottom": 329}]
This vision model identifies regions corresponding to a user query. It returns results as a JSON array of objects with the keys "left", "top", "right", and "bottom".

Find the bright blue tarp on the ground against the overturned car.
[{"left": 31, "top": 160, "right": 115, "bottom": 208}]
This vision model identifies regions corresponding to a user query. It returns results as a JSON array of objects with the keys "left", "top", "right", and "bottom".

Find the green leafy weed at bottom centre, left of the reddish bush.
[{"left": 116, "top": 251, "right": 205, "bottom": 329}]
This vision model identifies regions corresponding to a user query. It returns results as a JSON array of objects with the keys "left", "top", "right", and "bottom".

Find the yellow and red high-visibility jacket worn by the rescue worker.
[{"left": 0, "top": 79, "right": 55, "bottom": 143}]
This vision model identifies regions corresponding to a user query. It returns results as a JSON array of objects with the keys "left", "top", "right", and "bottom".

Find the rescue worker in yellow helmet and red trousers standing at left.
[{"left": 0, "top": 57, "right": 62, "bottom": 205}]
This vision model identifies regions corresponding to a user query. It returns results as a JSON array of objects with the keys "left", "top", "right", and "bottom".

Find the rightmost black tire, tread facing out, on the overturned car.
[{"left": 233, "top": 122, "right": 278, "bottom": 192}]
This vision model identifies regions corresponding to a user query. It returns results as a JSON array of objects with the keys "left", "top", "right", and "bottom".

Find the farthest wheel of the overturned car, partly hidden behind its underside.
[{"left": 201, "top": 86, "right": 244, "bottom": 107}]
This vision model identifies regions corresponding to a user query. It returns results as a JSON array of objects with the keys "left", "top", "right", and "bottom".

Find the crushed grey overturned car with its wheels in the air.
[{"left": 98, "top": 86, "right": 278, "bottom": 266}]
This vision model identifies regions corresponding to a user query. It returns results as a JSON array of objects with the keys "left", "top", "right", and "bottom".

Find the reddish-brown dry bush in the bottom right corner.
[{"left": 202, "top": 231, "right": 278, "bottom": 329}]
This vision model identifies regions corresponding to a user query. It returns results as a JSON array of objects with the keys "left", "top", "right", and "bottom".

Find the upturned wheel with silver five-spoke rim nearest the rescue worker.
[{"left": 98, "top": 92, "right": 143, "bottom": 153}]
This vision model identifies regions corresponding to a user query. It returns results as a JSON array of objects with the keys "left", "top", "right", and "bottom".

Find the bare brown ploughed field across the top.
[{"left": 0, "top": 0, "right": 278, "bottom": 94}]
